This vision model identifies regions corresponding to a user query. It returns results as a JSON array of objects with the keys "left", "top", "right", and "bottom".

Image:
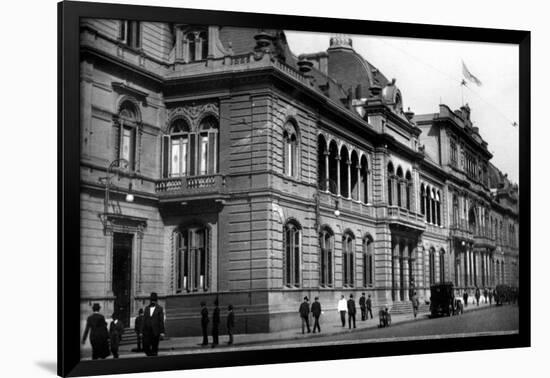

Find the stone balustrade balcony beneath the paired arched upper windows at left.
[{"left": 155, "top": 174, "right": 227, "bottom": 202}]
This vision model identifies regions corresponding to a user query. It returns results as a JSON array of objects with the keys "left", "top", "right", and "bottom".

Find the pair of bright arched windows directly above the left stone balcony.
[{"left": 163, "top": 116, "right": 218, "bottom": 177}]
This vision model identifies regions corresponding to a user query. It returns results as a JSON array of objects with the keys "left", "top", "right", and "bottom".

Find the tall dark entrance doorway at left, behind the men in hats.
[{"left": 113, "top": 233, "right": 133, "bottom": 327}]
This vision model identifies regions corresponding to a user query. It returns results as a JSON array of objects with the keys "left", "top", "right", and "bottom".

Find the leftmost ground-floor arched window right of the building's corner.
[{"left": 283, "top": 221, "right": 302, "bottom": 287}]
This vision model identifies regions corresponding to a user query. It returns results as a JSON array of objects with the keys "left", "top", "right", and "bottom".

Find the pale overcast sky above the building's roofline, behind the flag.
[{"left": 286, "top": 31, "right": 521, "bottom": 182}]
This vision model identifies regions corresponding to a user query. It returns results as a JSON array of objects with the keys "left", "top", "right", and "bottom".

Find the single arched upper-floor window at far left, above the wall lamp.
[{"left": 116, "top": 101, "right": 138, "bottom": 170}]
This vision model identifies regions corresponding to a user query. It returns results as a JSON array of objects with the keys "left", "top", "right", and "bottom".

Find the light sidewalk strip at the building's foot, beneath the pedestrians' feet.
[{"left": 94, "top": 303, "right": 495, "bottom": 359}]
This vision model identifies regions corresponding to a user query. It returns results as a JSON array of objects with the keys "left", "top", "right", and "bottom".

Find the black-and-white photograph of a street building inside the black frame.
[{"left": 79, "top": 10, "right": 524, "bottom": 359}]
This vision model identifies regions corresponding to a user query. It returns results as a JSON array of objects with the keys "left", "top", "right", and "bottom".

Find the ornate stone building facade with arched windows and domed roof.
[{"left": 80, "top": 20, "right": 519, "bottom": 336}]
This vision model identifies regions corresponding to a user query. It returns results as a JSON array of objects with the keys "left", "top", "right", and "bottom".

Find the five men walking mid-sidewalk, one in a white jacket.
[{"left": 298, "top": 293, "right": 373, "bottom": 333}]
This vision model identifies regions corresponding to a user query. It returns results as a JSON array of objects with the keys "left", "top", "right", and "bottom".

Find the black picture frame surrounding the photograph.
[{"left": 58, "top": 1, "right": 531, "bottom": 376}]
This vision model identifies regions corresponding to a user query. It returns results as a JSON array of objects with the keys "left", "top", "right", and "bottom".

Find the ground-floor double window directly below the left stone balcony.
[{"left": 174, "top": 227, "right": 210, "bottom": 293}]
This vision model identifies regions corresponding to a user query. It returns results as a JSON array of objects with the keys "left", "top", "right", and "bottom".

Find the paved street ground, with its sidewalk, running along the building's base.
[{"left": 83, "top": 304, "right": 518, "bottom": 359}]
